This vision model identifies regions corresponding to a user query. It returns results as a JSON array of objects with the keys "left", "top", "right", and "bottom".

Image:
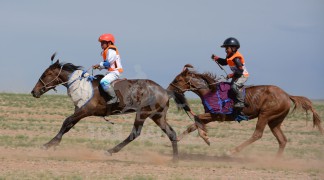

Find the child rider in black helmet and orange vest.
[{"left": 211, "top": 37, "right": 249, "bottom": 111}]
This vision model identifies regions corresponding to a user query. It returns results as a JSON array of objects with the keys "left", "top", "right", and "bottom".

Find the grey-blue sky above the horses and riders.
[{"left": 0, "top": 0, "right": 324, "bottom": 99}]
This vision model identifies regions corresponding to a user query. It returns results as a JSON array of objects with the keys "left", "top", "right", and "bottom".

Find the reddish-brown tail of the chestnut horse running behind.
[{"left": 289, "top": 96, "right": 324, "bottom": 134}]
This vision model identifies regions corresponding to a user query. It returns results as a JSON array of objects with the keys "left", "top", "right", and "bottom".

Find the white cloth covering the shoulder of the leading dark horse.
[{"left": 67, "top": 70, "right": 93, "bottom": 108}]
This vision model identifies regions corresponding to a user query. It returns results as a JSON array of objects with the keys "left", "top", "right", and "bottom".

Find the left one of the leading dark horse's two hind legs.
[{"left": 107, "top": 115, "right": 146, "bottom": 155}]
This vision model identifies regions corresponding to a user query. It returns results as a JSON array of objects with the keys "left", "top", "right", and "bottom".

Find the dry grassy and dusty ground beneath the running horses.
[{"left": 0, "top": 93, "right": 324, "bottom": 180}]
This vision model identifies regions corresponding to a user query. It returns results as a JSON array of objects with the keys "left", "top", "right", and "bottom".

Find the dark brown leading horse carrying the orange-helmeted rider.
[{"left": 31, "top": 55, "right": 189, "bottom": 159}]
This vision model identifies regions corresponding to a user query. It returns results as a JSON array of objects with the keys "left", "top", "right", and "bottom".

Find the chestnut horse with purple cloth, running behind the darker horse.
[{"left": 168, "top": 64, "right": 324, "bottom": 156}]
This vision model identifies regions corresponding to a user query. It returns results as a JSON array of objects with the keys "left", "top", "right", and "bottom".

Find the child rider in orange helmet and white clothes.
[{"left": 93, "top": 34, "right": 123, "bottom": 104}]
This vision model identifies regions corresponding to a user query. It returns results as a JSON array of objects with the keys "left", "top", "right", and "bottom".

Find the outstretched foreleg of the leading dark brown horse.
[{"left": 43, "top": 111, "right": 87, "bottom": 149}]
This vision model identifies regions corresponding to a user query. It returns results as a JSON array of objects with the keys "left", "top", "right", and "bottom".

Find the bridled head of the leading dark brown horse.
[{"left": 31, "top": 53, "right": 81, "bottom": 98}]
